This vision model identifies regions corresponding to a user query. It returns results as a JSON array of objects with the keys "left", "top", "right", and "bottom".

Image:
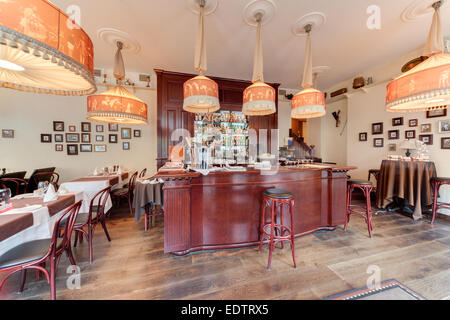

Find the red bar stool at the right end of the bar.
[{"left": 344, "top": 180, "right": 373, "bottom": 238}]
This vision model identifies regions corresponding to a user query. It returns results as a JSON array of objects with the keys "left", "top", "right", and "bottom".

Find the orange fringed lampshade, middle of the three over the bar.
[{"left": 242, "top": 81, "right": 277, "bottom": 116}]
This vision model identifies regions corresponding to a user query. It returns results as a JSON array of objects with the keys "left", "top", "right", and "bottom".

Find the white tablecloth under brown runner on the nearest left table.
[{"left": 0, "top": 192, "right": 83, "bottom": 256}]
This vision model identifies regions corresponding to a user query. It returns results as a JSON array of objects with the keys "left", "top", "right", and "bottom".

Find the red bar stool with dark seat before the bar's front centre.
[{"left": 259, "top": 189, "right": 297, "bottom": 269}]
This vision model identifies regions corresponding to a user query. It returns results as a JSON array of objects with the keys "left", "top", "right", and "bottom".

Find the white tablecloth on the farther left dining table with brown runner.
[{"left": 59, "top": 173, "right": 130, "bottom": 213}]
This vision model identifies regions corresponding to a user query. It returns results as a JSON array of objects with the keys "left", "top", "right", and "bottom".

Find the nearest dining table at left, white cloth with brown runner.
[{"left": 0, "top": 191, "right": 83, "bottom": 256}]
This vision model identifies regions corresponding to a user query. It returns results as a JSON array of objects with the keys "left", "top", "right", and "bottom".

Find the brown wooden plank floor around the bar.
[{"left": 0, "top": 205, "right": 450, "bottom": 299}]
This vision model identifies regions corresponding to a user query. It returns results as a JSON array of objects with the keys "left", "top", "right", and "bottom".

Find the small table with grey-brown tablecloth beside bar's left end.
[{"left": 133, "top": 181, "right": 164, "bottom": 223}]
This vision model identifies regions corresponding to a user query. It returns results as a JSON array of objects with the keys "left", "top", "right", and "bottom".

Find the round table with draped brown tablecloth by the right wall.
[{"left": 377, "top": 160, "right": 436, "bottom": 220}]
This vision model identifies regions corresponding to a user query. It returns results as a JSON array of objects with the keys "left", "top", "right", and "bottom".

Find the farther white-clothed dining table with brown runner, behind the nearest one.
[{"left": 59, "top": 172, "right": 129, "bottom": 213}]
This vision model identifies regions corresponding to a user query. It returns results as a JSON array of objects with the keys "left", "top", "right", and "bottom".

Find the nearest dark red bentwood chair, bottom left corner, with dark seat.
[{"left": 0, "top": 200, "right": 81, "bottom": 300}]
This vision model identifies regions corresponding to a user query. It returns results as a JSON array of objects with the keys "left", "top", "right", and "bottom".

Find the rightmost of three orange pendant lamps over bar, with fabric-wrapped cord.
[{"left": 291, "top": 24, "right": 326, "bottom": 119}]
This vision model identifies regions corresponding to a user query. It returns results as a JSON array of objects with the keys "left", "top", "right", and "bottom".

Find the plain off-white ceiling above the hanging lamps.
[{"left": 52, "top": 0, "right": 450, "bottom": 89}]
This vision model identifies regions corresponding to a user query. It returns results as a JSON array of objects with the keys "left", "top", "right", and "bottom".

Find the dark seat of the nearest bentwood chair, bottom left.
[{"left": 0, "top": 239, "right": 63, "bottom": 269}]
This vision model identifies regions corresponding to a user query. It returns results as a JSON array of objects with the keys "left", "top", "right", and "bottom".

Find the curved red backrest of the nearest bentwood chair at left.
[{"left": 49, "top": 200, "right": 82, "bottom": 256}]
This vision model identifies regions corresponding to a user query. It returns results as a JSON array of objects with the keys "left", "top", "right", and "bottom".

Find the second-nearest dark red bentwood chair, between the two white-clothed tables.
[{"left": 74, "top": 187, "right": 111, "bottom": 263}]
